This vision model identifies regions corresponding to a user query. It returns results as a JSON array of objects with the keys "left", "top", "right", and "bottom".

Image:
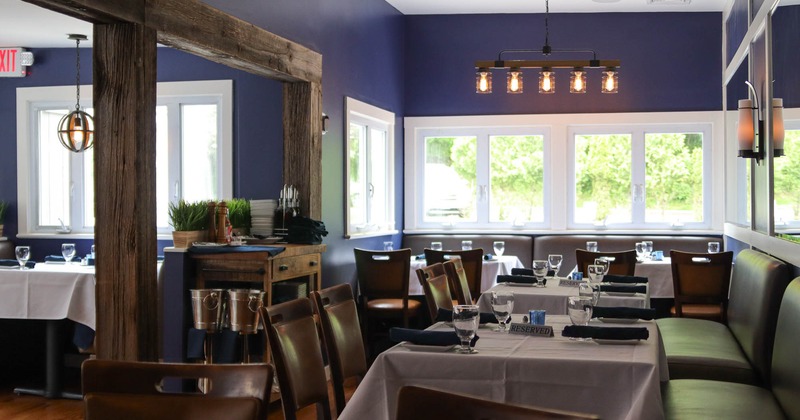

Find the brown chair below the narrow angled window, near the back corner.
[{"left": 353, "top": 248, "right": 422, "bottom": 347}]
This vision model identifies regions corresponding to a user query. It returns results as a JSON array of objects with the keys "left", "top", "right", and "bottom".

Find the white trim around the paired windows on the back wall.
[{"left": 403, "top": 111, "right": 725, "bottom": 234}]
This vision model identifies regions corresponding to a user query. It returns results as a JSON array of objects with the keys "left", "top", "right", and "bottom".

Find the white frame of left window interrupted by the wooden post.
[{"left": 17, "top": 80, "right": 233, "bottom": 239}]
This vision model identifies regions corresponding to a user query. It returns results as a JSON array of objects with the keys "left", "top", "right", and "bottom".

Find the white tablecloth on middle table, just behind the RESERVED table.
[{"left": 478, "top": 278, "right": 649, "bottom": 316}]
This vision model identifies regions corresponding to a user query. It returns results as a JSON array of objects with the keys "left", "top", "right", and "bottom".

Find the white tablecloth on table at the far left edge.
[{"left": 0, "top": 263, "right": 96, "bottom": 329}]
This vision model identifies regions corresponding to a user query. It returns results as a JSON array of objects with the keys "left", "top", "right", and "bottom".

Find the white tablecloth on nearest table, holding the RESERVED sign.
[{"left": 339, "top": 315, "right": 669, "bottom": 420}]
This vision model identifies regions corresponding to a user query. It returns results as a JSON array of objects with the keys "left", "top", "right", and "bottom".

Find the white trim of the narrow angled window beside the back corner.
[{"left": 344, "top": 97, "right": 399, "bottom": 239}]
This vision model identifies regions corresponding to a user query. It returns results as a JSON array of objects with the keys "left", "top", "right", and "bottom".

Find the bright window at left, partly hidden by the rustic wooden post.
[{"left": 17, "top": 81, "right": 232, "bottom": 236}]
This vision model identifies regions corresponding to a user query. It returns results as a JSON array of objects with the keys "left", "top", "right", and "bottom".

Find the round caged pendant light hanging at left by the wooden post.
[{"left": 58, "top": 34, "right": 94, "bottom": 153}]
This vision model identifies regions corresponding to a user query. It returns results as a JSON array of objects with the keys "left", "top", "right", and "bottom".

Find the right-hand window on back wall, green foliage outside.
[{"left": 570, "top": 125, "right": 711, "bottom": 228}]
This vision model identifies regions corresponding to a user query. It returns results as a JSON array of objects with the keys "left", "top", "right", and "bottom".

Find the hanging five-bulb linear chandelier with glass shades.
[{"left": 475, "top": 0, "right": 620, "bottom": 94}]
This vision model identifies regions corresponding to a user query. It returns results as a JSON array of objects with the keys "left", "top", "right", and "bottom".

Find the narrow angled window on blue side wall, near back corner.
[{"left": 345, "top": 98, "right": 397, "bottom": 237}]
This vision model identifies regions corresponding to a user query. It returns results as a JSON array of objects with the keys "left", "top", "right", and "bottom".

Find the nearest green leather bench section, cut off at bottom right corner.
[{"left": 662, "top": 277, "right": 800, "bottom": 420}]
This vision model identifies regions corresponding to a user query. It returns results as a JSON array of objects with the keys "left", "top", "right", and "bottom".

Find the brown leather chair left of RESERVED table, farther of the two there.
[{"left": 311, "top": 283, "right": 367, "bottom": 414}]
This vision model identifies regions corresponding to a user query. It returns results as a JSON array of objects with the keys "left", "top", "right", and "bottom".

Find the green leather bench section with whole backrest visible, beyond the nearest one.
[{"left": 656, "top": 249, "right": 796, "bottom": 385}]
